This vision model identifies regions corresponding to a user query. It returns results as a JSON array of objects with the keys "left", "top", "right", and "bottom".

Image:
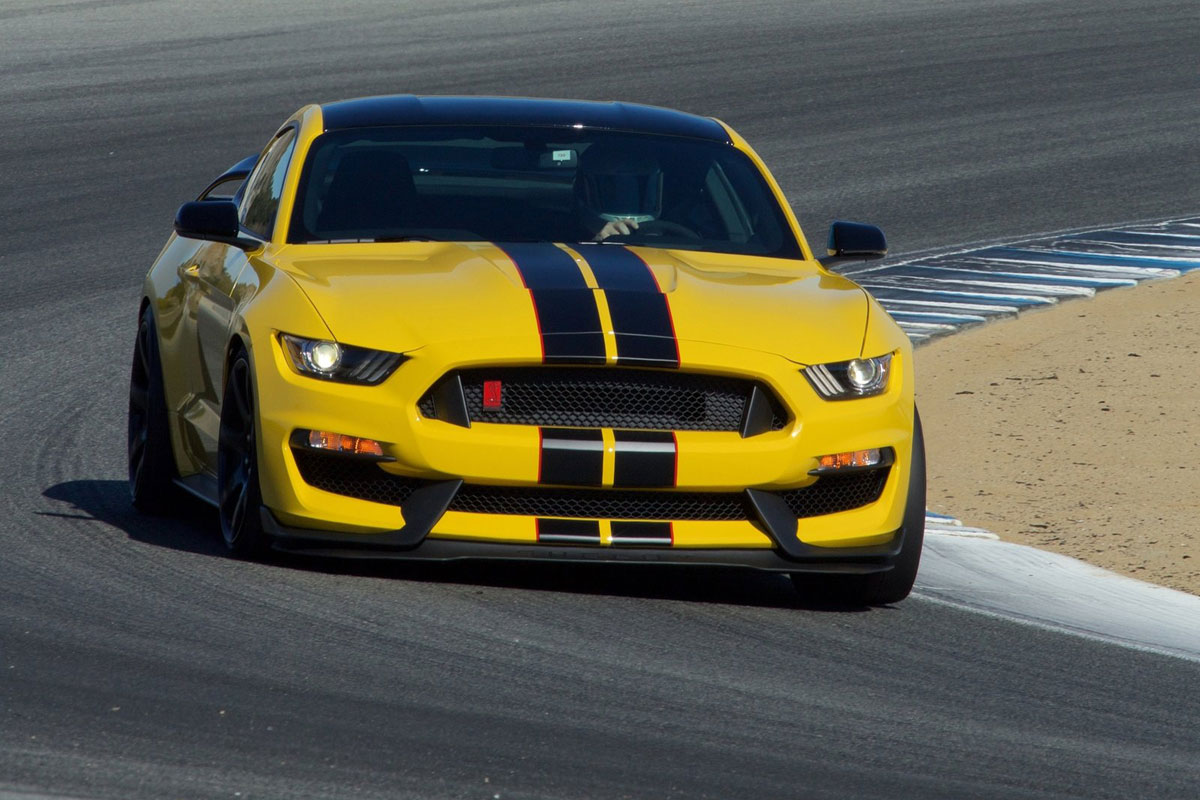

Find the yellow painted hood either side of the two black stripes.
[{"left": 275, "top": 242, "right": 868, "bottom": 363}]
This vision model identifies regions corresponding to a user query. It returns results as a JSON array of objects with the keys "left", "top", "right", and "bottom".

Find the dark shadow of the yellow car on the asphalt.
[{"left": 38, "top": 480, "right": 874, "bottom": 613}]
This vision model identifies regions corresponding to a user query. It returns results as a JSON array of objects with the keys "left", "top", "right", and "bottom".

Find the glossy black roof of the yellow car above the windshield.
[{"left": 320, "top": 95, "right": 730, "bottom": 143}]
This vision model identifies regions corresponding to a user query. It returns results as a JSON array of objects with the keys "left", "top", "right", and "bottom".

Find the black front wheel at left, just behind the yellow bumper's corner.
[{"left": 217, "top": 350, "right": 266, "bottom": 559}]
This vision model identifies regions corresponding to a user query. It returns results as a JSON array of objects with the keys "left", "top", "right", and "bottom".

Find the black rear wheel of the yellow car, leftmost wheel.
[{"left": 126, "top": 307, "right": 182, "bottom": 515}]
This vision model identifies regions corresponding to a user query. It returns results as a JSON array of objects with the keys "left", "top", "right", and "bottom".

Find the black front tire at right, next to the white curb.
[{"left": 792, "top": 409, "right": 925, "bottom": 606}]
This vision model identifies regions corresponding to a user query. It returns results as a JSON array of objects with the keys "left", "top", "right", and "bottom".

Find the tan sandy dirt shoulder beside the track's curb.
[{"left": 916, "top": 271, "right": 1200, "bottom": 595}]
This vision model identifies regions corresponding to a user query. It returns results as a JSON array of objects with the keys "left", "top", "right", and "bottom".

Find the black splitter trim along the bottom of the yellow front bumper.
[{"left": 260, "top": 506, "right": 904, "bottom": 575}]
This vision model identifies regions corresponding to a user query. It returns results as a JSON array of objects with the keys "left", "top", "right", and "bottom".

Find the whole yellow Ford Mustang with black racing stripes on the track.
[{"left": 128, "top": 96, "right": 925, "bottom": 603}]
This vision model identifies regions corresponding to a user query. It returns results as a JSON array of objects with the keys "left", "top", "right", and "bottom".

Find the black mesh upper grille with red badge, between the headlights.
[{"left": 418, "top": 367, "right": 787, "bottom": 431}]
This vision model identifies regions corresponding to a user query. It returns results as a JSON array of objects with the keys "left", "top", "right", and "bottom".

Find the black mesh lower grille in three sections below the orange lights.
[{"left": 293, "top": 449, "right": 889, "bottom": 521}]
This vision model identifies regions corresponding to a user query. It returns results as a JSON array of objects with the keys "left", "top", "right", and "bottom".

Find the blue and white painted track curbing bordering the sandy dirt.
[{"left": 841, "top": 217, "right": 1200, "bottom": 661}]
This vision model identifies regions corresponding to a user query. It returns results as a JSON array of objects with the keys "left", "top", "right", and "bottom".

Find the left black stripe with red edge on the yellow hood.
[{"left": 496, "top": 242, "right": 606, "bottom": 363}]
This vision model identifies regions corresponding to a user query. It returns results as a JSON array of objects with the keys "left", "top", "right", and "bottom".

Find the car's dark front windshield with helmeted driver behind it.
[{"left": 288, "top": 127, "right": 800, "bottom": 258}]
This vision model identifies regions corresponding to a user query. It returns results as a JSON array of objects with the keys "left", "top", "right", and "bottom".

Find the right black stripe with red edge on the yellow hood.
[{"left": 580, "top": 245, "right": 679, "bottom": 367}]
